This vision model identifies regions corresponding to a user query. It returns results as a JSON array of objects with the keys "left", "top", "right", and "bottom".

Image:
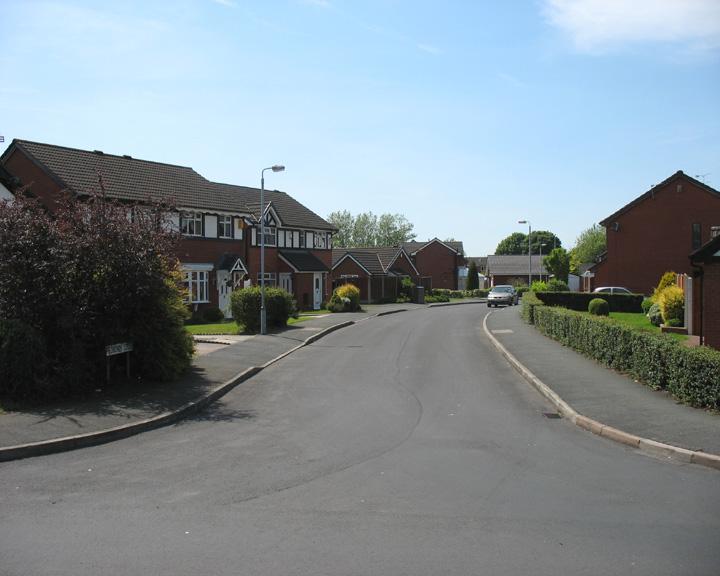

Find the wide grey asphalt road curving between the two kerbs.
[{"left": 0, "top": 306, "right": 720, "bottom": 576}]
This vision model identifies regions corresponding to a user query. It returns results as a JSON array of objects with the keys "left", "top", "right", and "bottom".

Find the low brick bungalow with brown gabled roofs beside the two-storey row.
[{"left": 331, "top": 247, "right": 420, "bottom": 303}]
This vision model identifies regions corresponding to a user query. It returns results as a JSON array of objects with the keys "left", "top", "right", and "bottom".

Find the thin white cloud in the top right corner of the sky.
[{"left": 543, "top": 0, "right": 720, "bottom": 52}]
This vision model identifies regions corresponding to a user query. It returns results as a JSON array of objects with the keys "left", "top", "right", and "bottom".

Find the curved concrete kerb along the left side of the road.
[{"left": 0, "top": 320, "right": 355, "bottom": 462}]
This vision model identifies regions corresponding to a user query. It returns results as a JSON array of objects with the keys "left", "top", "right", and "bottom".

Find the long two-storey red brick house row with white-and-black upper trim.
[{"left": 0, "top": 140, "right": 336, "bottom": 312}]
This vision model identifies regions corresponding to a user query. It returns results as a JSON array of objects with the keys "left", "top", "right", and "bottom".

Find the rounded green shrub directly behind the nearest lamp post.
[{"left": 230, "top": 286, "right": 297, "bottom": 332}]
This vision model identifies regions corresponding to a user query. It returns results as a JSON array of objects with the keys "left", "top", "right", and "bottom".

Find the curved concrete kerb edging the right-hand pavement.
[{"left": 483, "top": 312, "right": 720, "bottom": 470}]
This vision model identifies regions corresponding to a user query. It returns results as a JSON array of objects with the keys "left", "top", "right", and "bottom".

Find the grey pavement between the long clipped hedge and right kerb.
[{"left": 487, "top": 306, "right": 720, "bottom": 455}]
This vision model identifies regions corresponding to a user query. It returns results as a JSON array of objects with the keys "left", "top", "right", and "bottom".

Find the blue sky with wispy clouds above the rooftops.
[{"left": 0, "top": 0, "right": 720, "bottom": 255}]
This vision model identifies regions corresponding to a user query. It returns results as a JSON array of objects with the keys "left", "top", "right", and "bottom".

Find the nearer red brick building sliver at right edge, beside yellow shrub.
[{"left": 690, "top": 234, "right": 720, "bottom": 350}]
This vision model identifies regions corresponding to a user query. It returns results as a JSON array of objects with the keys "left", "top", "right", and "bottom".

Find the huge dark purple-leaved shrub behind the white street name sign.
[{"left": 0, "top": 194, "right": 193, "bottom": 399}]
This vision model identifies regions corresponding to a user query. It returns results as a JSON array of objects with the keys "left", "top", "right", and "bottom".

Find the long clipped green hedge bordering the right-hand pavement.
[{"left": 523, "top": 306, "right": 720, "bottom": 410}]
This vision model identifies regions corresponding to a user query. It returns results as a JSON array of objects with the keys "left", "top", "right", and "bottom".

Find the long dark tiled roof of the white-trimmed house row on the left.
[{"left": 8, "top": 140, "right": 336, "bottom": 231}]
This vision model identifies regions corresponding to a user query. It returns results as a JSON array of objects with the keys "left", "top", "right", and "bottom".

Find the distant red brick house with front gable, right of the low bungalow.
[{"left": 403, "top": 238, "right": 466, "bottom": 290}]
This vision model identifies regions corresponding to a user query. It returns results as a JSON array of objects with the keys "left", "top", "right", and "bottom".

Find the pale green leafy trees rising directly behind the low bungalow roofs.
[{"left": 327, "top": 210, "right": 415, "bottom": 248}]
